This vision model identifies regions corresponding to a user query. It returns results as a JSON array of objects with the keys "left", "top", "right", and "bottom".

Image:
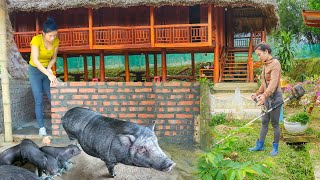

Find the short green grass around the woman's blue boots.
[{"left": 210, "top": 115, "right": 314, "bottom": 180}]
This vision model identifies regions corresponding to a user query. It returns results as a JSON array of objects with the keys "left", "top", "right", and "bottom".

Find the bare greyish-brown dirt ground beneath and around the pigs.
[{"left": 0, "top": 138, "right": 198, "bottom": 180}]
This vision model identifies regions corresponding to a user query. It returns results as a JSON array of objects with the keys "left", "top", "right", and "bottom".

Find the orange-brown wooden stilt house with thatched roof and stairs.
[{"left": 8, "top": 0, "right": 278, "bottom": 83}]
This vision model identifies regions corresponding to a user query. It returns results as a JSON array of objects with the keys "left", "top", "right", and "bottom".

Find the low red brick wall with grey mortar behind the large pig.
[{"left": 51, "top": 82, "right": 200, "bottom": 144}]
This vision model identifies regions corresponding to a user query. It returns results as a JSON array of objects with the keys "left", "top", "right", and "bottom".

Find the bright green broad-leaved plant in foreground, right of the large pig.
[{"left": 197, "top": 139, "right": 271, "bottom": 180}]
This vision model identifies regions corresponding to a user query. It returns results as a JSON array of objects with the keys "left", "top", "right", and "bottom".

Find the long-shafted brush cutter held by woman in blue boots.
[{"left": 215, "top": 84, "right": 306, "bottom": 145}]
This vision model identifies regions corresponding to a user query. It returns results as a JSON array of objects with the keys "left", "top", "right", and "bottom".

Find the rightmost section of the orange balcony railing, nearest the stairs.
[{"left": 154, "top": 24, "right": 208, "bottom": 44}]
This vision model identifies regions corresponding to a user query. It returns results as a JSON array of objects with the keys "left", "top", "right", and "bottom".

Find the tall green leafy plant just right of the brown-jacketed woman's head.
[{"left": 275, "top": 31, "right": 295, "bottom": 72}]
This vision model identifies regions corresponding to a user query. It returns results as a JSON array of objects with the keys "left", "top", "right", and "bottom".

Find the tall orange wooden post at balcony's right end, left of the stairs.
[{"left": 213, "top": 7, "right": 220, "bottom": 83}]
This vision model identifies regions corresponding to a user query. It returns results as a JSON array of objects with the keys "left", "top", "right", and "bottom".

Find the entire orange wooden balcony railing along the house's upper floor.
[{"left": 14, "top": 24, "right": 214, "bottom": 52}]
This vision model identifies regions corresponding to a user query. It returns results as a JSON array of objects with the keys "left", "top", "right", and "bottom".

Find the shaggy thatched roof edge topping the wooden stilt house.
[{"left": 8, "top": 0, "right": 279, "bottom": 31}]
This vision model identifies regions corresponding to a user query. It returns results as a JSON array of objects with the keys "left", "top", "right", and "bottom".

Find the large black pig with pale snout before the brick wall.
[{"left": 62, "top": 107, "right": 175, "bottom": 177}]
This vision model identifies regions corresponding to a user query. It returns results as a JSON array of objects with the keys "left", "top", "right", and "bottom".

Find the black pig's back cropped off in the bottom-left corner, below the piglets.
[{"left": 0, "top": 165, "right": 41, "bottom": 180}]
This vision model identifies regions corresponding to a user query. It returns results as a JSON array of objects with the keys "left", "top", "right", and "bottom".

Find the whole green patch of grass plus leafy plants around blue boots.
[{"left": 197, "top": 116, "right": 314, "bottom": 180}]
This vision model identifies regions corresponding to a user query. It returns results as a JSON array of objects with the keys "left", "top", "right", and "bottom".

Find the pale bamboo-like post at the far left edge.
[{"left": 0, "top": 1, "right": 13, "bottom": 142}]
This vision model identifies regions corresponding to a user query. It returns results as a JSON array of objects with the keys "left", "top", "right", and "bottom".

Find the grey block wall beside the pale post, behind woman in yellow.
[{"left": 0, "top": 79, "right": 35, "bottom": 133}]
